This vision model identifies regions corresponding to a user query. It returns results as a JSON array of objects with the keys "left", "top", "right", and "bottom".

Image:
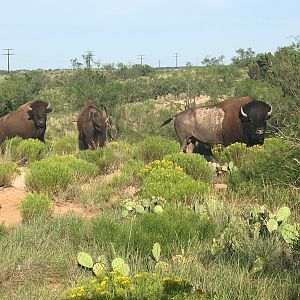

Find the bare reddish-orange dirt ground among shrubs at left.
[{"left": 0, "top": 171, "right": 92, "bottom": 225}]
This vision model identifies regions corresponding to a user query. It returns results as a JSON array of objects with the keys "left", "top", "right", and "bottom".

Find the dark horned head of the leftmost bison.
[{"left": 27, "top": 100, "right": 52, "bottom": 128}]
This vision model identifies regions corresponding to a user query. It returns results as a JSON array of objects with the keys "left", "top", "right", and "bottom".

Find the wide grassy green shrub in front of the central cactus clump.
[{"left": 132, "top": 206, "right": 216, "bottom": 255}]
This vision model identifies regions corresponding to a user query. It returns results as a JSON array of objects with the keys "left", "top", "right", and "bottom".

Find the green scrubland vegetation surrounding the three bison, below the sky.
[{"left": 0, "top": 40, "right": 300, "bottom": 300}]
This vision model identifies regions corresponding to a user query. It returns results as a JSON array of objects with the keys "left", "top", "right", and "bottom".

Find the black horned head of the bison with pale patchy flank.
[{"left": 239, "top": 101, "right": 272, "bottom": 146}]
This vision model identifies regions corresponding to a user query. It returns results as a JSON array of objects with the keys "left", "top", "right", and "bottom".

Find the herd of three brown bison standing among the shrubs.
[{"left": 0, "top": 97, "right": 272, "bottom": 157}]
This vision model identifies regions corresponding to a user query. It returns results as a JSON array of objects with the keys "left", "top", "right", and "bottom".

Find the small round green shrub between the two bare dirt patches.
[{"left": 20, "top": 193, "right": 53, "bottom": 221}]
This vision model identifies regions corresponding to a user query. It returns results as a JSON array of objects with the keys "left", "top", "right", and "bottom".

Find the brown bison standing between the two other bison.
[{"left": 77, "top": 101, "right": 109, "bottom": 150}]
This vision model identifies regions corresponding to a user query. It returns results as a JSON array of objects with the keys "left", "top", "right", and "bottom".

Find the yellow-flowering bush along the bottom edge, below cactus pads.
[{"left": 62, "top": 271, "right": 205, "bottom": 300}]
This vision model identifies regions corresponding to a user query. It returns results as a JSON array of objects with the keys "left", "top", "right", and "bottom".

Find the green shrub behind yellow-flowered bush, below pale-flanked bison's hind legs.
[{"left": 164, "top": 153, "right": 213, "bottom": 182}]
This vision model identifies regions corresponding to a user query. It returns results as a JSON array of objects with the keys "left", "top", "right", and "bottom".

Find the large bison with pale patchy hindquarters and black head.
[{"left": 161, "top": 97, "right": 272, "bottom": 152}]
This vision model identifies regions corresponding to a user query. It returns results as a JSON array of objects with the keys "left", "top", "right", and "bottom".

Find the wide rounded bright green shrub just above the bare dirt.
[{"left": 25, "top": 155, "right": 98, "bottom": 194}]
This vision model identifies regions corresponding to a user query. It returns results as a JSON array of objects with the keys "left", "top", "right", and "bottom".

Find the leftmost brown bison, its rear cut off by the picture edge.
[{"left": 0, "top": 100, "right": 52, "bottom": 145}]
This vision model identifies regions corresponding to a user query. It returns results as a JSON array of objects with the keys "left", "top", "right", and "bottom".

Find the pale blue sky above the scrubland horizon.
[{"left": 0, "top": 0, "right": 300, "bottom": 70}]
